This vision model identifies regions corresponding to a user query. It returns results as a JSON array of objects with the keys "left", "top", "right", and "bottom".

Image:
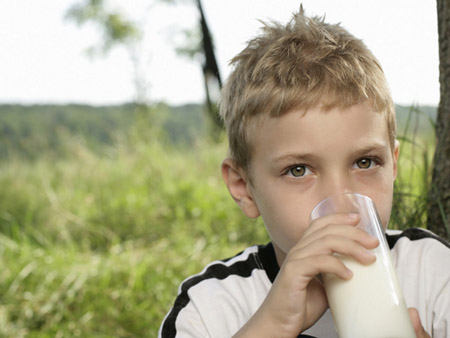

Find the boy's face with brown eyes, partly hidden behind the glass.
[{"left": 222, "top": 104, "right": 398, "bottom": 262}]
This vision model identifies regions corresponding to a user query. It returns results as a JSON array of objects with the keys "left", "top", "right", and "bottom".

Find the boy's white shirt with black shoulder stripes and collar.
[{"left": 159, "top": 229, "right": 450, "bottom": 338}]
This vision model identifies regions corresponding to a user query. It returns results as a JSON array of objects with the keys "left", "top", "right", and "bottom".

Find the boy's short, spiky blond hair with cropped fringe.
[{"left": 220, "top": 7, "right": 396, "bottom": 172}]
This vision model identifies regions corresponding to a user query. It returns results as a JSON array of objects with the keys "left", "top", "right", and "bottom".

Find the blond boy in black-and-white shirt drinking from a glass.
[{"left": 159, "top": 8, "right": 450, "bottom": 338}]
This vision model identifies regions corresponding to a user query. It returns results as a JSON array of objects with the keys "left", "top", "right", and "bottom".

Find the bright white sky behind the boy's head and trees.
[{"left": 0, "top": 0, "right": 439, "bottom": 105}]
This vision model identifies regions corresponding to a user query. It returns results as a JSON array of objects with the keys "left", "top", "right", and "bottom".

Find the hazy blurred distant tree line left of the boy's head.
[{"left": 0, "top": 103, "right": 206, "bottom": 160}]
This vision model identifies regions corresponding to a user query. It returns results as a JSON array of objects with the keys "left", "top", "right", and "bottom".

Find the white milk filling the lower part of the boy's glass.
[{"left": 324, "top": 246, "right": 415, "bottom": 338}]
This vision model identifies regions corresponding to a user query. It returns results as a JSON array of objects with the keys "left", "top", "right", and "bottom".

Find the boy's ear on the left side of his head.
[{"left": 221, "top": 158, "right": 259, "bottom": 218}]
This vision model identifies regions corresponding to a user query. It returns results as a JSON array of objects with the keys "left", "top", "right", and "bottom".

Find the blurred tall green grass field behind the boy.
[{"left": 0, "top": 105, "right": 433, "bottom": 337}]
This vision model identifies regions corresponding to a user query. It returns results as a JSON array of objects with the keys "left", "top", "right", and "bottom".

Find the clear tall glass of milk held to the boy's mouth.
[{"left": 311, "top": 193, "right": 415, "bottom": 338}]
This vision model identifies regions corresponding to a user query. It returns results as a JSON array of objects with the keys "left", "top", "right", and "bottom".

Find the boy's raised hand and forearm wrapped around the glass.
[{"left": 235, "top": 214, "right": 379, "bottom": 337}]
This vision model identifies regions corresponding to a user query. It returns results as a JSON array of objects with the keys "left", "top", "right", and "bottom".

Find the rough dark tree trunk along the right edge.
[{"left": 427, "top": 0, "right": 450, "bottom": 239}]
